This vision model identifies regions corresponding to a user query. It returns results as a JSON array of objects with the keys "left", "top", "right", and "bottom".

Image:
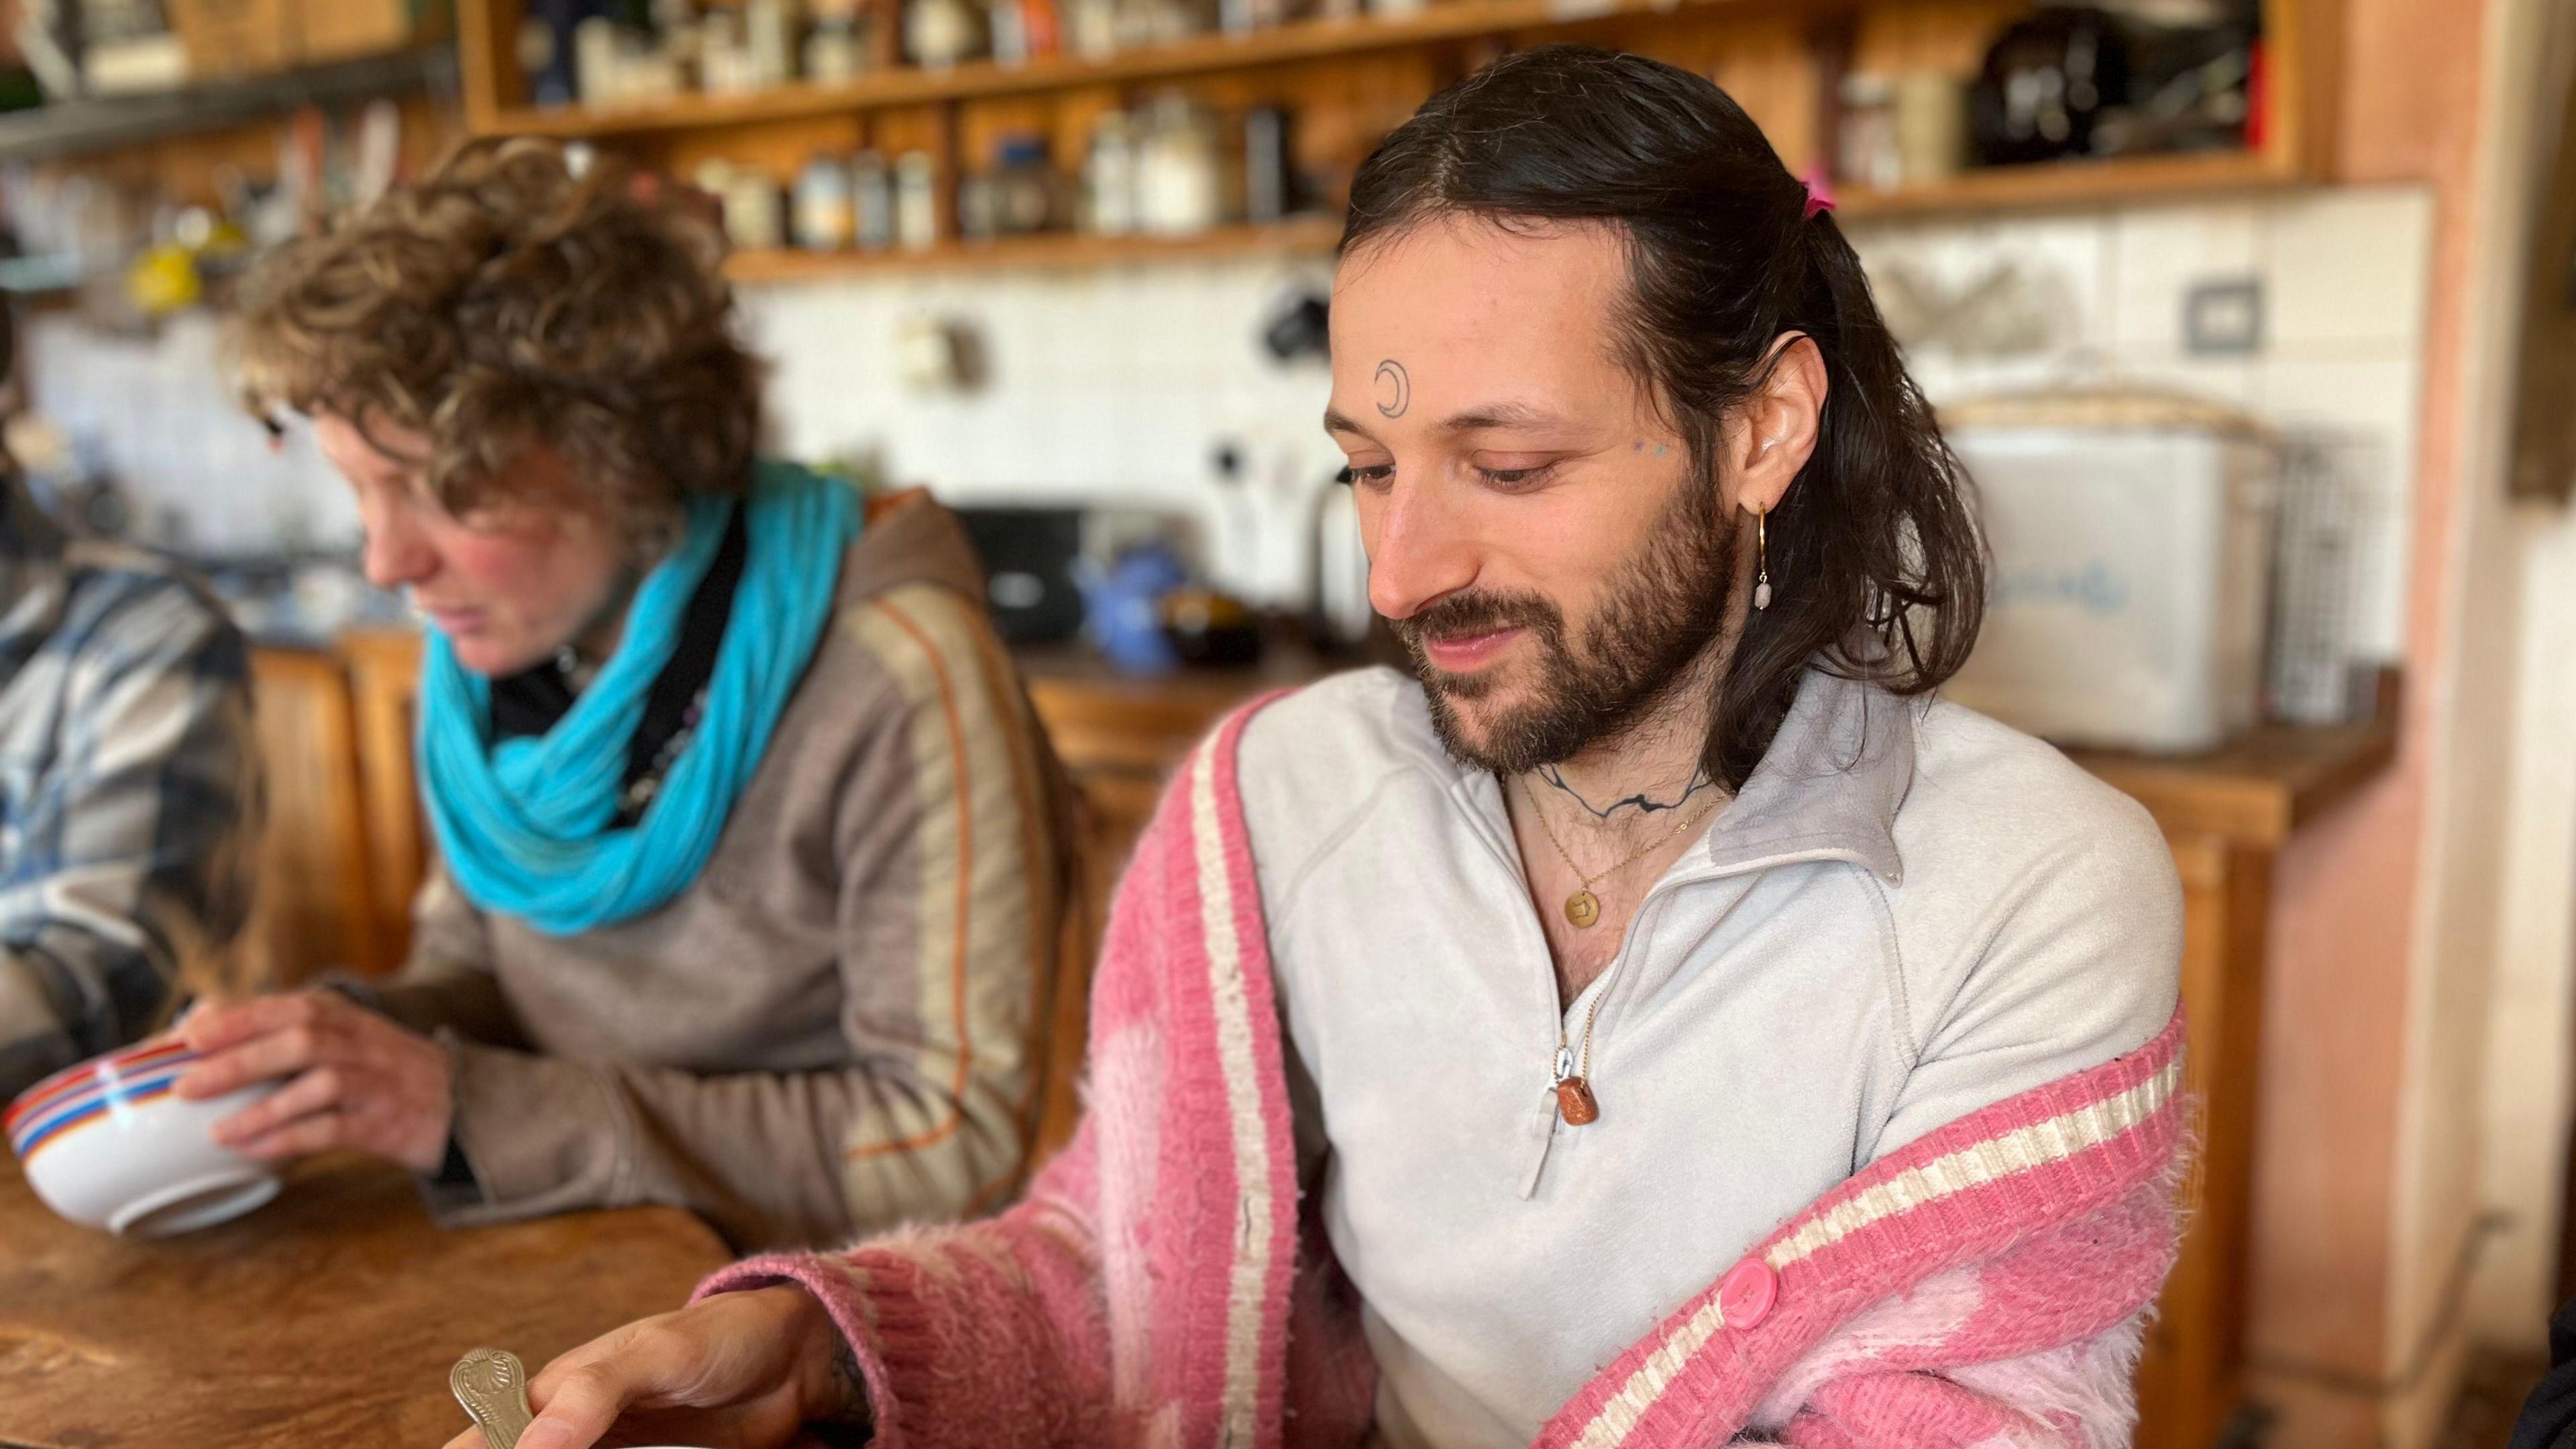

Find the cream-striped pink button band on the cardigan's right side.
[{"left": 1538, "top": 1011, "right": 2182, "bottom": 1449}]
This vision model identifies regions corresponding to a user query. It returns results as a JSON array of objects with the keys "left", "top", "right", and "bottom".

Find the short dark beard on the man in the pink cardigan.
[{"left": 1391, "top": 469, "right": 1736, "bottom": 776}]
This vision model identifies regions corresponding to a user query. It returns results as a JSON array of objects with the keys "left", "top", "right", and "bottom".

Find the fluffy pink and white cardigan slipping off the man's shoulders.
[{"left": 698, "top": 696, "right": 2184, "bottom": 1449}]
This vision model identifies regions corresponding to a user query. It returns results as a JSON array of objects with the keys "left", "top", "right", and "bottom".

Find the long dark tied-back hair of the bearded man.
[{"left": 1342, "top": 46, "right": 1986, "bottom": 789}]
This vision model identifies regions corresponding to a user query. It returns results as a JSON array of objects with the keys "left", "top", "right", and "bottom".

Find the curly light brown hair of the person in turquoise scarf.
[{"left": 227, "top": 140, "right": 760, "bottom": 534}]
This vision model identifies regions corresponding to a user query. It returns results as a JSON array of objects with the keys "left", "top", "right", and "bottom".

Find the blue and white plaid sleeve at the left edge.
[{"left": 0, "top": 570, "right": 258, "bottom": 1095}]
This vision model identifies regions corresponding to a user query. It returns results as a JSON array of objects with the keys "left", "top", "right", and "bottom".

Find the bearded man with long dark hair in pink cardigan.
[{"left": 453, "top": 49, "right": 2182, "bottom": 1449}]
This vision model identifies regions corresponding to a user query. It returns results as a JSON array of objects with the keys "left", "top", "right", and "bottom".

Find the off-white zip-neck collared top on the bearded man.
[{"left": 1239, "top": 670, "right": 2182, "bottom": 1449}]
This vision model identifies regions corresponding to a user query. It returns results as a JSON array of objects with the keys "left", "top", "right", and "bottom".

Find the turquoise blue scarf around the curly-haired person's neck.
[{"left": 420, "top": 462, "right": 861, "bottom": 936}]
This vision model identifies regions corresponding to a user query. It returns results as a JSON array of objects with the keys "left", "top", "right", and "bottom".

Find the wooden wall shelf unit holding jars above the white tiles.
[{"left": 459, "top": 0, "right": 2342, "bottom": 281}]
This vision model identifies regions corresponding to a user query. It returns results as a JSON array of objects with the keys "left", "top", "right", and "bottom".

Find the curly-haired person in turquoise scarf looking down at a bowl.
[{"left": 180, "top": 142, "right": 1071, "bottom": 1245}]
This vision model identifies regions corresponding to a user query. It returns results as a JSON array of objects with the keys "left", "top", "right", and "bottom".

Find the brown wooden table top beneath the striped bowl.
[{"left": 0, "top": 1158, "right": 729, "bottom": 1449}]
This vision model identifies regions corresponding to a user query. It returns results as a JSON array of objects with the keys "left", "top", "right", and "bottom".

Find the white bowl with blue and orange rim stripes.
[{"left": 0, "top": 1042, "right": 278, "bottom": 1238}]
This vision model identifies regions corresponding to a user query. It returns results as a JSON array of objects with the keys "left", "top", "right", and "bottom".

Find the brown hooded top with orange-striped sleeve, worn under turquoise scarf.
[{"left": 371, "top": 500, "right": 1071, "bottom": 1248}]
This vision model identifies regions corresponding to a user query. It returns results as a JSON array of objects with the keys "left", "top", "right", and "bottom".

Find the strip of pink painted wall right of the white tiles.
[{"left": 2249, "top": 0, "right": 2486, "bottom": 1449}]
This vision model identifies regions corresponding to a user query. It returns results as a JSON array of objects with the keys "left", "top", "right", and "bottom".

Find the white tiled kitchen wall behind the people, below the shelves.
[{"left": 28, "top": 189, "right": 2432, "bottom": 657}]
